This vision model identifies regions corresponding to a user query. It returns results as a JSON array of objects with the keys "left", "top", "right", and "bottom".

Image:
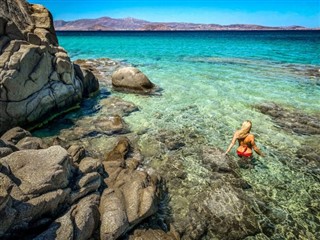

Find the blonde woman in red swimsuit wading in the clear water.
[{"left": 226, "top": 120, "right": 264, "bottom": 158}]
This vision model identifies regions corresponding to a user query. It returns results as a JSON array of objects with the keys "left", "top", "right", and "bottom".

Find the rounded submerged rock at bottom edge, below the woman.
[{"left": 187, "top": 181, "right": 260, "bottom": 239}]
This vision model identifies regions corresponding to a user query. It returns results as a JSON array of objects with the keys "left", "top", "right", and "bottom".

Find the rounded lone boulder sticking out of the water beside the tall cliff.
[{"left": 112, "top": 67, "right": 155, "bottom": 94}]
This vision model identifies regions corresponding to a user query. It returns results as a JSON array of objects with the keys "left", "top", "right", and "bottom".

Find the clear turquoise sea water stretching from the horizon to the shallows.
[{"left": 38, "top": 31, "right": 320, "bottom": 239}]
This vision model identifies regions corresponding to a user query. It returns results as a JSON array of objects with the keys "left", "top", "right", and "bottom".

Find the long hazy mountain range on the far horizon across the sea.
[{"left": 54, "top": 17, "right": 314, "bottom": 31}]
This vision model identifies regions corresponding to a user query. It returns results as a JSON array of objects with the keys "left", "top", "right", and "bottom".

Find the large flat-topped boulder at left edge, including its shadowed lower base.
[{"left": 0, "top": 146, "right": 72, "bottom": 236}]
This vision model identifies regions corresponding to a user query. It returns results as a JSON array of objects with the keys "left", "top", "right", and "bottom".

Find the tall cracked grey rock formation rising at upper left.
[{"left": 0, "top": 0, "right": 99, "bottom": 133}]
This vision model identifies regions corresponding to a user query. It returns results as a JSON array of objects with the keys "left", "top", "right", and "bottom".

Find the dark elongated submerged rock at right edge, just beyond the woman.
[{"left": 254, "top": 102, "right": 320, "bottom": 135}]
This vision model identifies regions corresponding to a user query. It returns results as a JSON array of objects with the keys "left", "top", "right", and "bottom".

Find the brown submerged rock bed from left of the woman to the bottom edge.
[{"left": 140, "top": 127, "right": 265, "bottom": 239}]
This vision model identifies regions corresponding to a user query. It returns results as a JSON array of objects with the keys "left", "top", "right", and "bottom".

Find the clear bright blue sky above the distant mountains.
[{"left": 30, "top": 0, "right": 320, "bottom": 27}]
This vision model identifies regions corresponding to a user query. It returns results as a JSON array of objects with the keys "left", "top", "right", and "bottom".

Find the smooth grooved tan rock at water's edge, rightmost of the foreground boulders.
[{"left": 100, "top": 138, "right": 159, "bottom": 239}]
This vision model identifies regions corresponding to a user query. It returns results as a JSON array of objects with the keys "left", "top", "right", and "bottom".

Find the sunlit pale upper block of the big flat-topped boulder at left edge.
[{"left": 0, "top": 146, "right": 71, "bottom": 196}]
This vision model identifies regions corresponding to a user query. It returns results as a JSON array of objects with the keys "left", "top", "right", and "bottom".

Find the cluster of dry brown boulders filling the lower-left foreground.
[{"left": 0, "top": 128, "right": 160, "bottom": 240}]
